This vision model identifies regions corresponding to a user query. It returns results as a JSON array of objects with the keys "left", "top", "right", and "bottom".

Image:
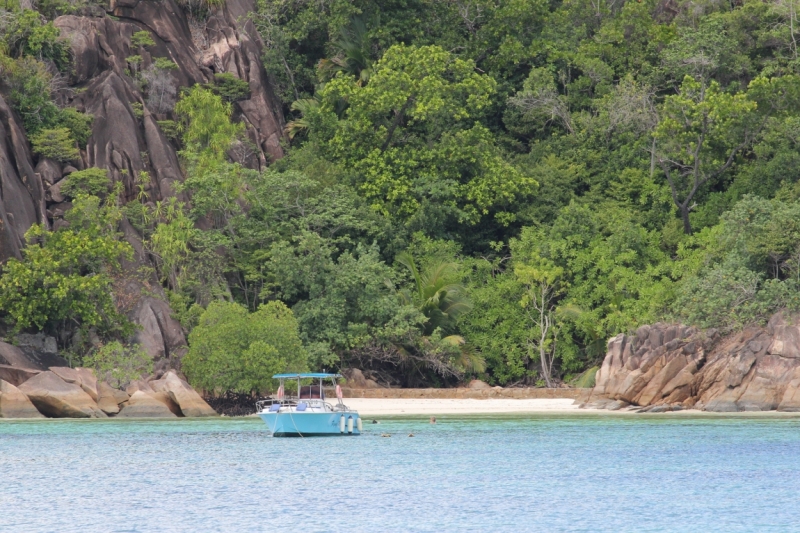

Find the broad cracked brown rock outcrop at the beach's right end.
[{"left": 590, "top": 314, "right": 800, "bottom": 412}]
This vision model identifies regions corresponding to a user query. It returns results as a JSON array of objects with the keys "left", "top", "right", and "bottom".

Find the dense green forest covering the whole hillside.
[{"left": 0, "top": 0, "right": 800, "bottom": 391}]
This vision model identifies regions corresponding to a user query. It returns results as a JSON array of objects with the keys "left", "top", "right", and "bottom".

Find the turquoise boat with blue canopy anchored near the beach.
[{"left": 256, "top": 373, "right": 362, "bottom": 437}]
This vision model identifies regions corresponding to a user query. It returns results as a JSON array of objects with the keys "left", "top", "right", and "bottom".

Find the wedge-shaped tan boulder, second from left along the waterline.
[{"left": 19, "top": 371, "right": 106, "bottom": 418}]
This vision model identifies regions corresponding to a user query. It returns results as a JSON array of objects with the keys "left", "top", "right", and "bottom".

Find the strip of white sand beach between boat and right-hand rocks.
[{"left": 344, "top": 398, "right": 583, "bottom": 416}]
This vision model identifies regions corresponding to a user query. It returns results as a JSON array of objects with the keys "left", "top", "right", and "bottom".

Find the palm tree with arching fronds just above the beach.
[{"left": 396, "top": 253, "right": 486, "bottom": 373}]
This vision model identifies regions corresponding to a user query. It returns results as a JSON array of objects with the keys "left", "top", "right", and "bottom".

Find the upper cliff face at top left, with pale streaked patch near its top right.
[{"left": 54, "top": 0, "right": 284, "bottom": 196}]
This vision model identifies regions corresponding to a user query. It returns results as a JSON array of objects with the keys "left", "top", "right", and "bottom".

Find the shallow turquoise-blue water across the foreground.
[{"left": 0, "top": 416, "right": 800, "bottom": 533}]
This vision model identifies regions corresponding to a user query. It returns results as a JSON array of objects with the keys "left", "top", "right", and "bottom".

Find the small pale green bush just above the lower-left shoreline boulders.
[{"left": 83, "top": 341, "right": 153, "bottom": 388}]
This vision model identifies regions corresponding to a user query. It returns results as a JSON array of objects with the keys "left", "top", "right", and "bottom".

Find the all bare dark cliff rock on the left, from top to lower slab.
[{"left": 0, "top": 0, "right": 284, "bottom": 374}]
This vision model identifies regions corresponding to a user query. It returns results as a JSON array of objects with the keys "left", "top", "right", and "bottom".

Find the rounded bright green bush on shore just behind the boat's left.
[{"left": 183, "top": 301, "right": 307, "bottom": 392}]
